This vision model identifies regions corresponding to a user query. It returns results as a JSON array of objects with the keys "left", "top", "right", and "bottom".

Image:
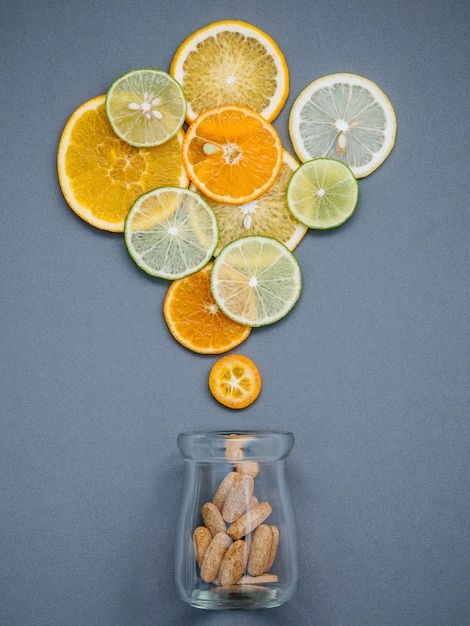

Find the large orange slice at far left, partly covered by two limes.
[{"left": 57, "top": 95, "right": 189, "bottom": 233}]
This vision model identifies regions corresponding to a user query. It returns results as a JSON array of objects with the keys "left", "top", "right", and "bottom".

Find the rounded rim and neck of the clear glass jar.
[{"left": 177, "top": 430, "right": 294, "bottom": 462}]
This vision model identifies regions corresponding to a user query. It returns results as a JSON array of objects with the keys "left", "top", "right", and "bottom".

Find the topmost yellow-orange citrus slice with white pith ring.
[{"left": 170, "top": 20, "right": 289, "bottom": 123}]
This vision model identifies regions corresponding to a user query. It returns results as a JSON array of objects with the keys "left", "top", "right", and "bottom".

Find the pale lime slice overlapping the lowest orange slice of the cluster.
[{"left": 211, "top": 235, "right": 302, "bottom": 326}]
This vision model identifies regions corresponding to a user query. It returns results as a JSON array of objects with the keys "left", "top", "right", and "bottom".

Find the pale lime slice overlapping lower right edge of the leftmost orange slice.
[{"left": 124, "top": 187, "right": 218, "bottom": 280}]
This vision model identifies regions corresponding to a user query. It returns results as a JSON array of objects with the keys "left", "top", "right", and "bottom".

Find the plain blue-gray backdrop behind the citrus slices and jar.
[{"left": 0, "top": 0, "right": 470, "bottom": 626}]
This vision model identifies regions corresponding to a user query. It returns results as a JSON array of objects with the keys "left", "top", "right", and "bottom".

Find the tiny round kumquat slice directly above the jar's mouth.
[{"left": 209, "top": 354, "right": 261, "bottom": 409}]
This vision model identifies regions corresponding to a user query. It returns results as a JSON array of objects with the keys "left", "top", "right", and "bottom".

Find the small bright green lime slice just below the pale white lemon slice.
[{"left": 287, "top": 159, "right": 359, "bottom": 229}]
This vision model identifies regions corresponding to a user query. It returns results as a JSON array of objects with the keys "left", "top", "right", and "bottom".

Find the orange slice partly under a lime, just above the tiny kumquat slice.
[{"left": 163, "top": 263, "right": 251, "bottom": 354}]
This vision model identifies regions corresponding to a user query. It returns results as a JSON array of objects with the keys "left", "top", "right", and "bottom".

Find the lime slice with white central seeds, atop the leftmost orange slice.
[{"left": 106, "top": 69, "right": 186, "bottom": 148}]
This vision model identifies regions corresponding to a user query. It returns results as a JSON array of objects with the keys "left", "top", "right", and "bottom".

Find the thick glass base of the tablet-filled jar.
[{"left": 189, "top": 585, "right": 282, "bottom": 610}]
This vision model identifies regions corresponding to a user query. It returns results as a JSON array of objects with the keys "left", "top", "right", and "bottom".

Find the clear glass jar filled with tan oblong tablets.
[{"left": 175, "top": 431, "right": 298, "bottom": 609}]
